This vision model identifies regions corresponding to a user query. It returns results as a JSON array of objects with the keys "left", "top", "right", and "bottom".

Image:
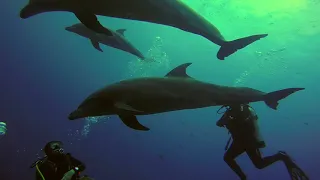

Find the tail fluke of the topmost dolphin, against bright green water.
[{"left": 217, "top": 34, "right": 268, "bottom": 60}]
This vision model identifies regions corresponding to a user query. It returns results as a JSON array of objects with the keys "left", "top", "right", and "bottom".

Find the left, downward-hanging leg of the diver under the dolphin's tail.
[{"left": 223, "top": 141, "right": 247, "bottom": 180}]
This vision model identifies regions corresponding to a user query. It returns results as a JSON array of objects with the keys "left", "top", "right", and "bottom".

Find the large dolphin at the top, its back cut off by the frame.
[{"left": 20, "top": 0, "right": 267, "bottom": 60}]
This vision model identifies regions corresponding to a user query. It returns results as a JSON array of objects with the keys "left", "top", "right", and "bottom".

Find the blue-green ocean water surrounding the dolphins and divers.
[{"left": 0, "top": 0, "right": 320, "bottom": 180}]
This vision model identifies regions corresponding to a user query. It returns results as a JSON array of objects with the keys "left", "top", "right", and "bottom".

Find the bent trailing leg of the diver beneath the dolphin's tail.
[{"left": 246, "top": 148, "right": 285, "bottom": 169}]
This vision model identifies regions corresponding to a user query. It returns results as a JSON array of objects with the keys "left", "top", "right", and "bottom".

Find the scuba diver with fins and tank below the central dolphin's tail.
[{"left": 216, "top": 104, "right": 309, "bottom": 180}]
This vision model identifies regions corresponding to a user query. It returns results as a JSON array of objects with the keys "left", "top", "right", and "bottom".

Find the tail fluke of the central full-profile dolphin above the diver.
[{"left": 265, "top": 88, "right": 305, "bottom": 110}]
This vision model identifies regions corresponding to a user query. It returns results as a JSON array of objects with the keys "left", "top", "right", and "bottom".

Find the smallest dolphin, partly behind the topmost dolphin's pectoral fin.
[{"left": 65, "top": 23, "right": 146, "bottom": 60}]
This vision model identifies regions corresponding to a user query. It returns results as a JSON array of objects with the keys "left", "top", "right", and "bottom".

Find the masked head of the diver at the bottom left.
[{"left": 43, "top": 141, "right": 64, "bottom": 158}]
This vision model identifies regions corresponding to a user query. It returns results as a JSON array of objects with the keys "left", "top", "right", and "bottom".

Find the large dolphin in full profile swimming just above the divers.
[{"left": 68, "top": 63, "right": 304, "bottom": 131}]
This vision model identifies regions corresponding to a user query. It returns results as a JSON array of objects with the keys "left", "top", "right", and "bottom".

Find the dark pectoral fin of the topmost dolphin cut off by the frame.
[{"left": 74, "top": 11, "right": 113, "bottom": 36}]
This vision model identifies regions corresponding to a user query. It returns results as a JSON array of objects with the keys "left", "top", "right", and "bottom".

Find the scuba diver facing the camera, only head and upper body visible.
[{"left": 30, "top": 141, "right": 91, "bottom": 180}]
